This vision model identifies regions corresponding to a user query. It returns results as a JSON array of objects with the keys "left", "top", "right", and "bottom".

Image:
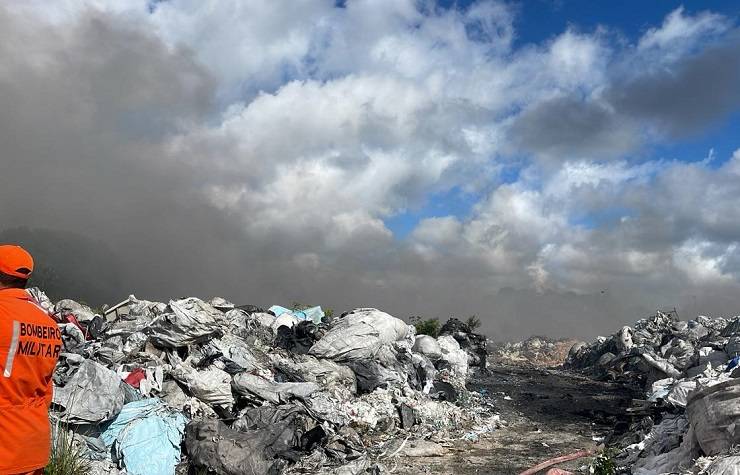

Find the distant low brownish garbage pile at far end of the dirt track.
[{"left": 488, "top": 336, "right": 577, "bottom": 368}]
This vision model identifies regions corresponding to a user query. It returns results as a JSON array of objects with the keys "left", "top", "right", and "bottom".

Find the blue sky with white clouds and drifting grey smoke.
[{"left": 0, "top": 0, "right": 740, "bottom": 339}]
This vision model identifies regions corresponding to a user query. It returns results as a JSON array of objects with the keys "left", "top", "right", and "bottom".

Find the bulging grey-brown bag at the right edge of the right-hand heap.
[{"left": 686, "top": 379, "right": 740, "bottom": 455}]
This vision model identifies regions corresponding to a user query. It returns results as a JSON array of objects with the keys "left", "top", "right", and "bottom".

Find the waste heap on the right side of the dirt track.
[{"left": 565, "top": 311, "right": 740, "bottom": 475}]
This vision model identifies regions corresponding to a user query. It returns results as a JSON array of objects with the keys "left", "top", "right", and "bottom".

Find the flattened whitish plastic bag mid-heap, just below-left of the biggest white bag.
[{"left": 273, "top": 355, "right": 357, "bottom": 393}]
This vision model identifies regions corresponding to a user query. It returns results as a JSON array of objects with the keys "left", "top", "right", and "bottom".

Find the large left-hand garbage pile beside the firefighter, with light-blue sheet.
[{"left": 37, "top": 289, "right": 499, "bottom": 475}]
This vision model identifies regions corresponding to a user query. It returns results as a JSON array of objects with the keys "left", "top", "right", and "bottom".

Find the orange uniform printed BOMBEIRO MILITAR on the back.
[{"left": 0, "top": 289, "right": 62, "bottom": 475}]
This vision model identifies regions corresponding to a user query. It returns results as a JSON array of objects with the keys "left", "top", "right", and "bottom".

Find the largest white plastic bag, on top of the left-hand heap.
[{"left": 309, "top": 308, "right": 415, "bottom": 362}]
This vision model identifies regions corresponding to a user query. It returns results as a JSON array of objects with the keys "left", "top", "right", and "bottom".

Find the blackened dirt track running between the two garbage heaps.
[{"left": 389, "top": 365, "right": 636, "bottom": 475}]
